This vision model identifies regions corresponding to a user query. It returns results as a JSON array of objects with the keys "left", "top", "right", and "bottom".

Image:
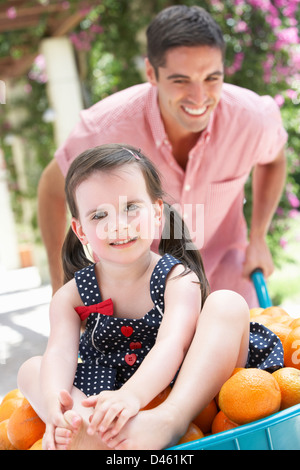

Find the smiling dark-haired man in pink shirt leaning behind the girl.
[{"left": 39, "top": 5, "right": 287, "bottom": 307}]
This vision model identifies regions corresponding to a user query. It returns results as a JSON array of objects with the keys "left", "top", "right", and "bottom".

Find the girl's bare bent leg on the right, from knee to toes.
[{"left": 103, "top": 290, "right": 249, "bottom": 450}]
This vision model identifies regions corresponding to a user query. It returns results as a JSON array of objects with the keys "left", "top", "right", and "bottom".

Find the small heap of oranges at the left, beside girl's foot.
[{"left": 0, "top": 389, "right": 45, "bottom": 450}]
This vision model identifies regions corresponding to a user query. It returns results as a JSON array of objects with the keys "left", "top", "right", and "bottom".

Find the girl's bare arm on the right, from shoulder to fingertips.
[{"left": 85, "top": 265, "right": 201, "bottom": 434}]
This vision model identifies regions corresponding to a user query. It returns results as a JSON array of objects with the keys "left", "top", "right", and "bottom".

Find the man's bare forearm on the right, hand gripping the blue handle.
[{"left": 243, "top": 149, "right": 286, "bottom": 277}]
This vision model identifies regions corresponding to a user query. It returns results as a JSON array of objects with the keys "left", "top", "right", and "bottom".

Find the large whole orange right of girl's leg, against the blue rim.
[{"left": 219, "top": 369, "right": 281, "bottom": 424}]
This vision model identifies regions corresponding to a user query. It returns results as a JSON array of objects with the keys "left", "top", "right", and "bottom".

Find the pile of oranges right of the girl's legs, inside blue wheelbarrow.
[{"left": 179, "top": 307, "right": 300, "bottom": 443}]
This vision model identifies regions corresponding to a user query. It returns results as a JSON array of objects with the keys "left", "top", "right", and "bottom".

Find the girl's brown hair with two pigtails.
[{"left": 62, "top": 144, "right": 209, "bottom": 302}]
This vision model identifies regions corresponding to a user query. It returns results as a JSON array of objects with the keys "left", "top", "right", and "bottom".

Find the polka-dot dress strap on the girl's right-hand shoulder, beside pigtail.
[{"left": 150, "top": 253, "right": 181, "bottom": 311}]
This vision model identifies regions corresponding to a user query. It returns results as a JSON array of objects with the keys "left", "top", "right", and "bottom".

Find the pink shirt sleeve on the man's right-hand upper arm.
[{"left": 257, "top": 96, "right": 288, "bottom": 164}]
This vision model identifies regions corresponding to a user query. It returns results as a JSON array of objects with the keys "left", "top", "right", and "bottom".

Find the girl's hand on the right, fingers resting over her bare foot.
[{"left": 82, "top": 389, "right": 140, "bottom": 437}]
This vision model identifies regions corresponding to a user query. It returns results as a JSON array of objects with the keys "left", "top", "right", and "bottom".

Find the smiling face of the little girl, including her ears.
[{"left": 72, "top": 165, "right": 163, "bottom": 263}]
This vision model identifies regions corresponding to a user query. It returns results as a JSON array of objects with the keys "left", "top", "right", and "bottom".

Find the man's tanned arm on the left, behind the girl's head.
[{"left": 38, "top": 160, "right": 66, "bottom": 293}]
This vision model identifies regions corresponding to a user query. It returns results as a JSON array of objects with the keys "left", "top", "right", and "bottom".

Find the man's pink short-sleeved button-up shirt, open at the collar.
[{"left": 55, "top": 83, "right": 287, "bottom": 303}]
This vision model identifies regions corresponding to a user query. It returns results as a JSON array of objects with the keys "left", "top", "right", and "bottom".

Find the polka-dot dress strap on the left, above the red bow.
[{"left": 75, "top": 264, "right": 102, "bottom": 305}]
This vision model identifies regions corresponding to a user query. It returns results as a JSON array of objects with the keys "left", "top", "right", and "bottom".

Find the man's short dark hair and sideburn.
[{"left": 147, "top": 5, "right": 225, "bottom": 76}]
